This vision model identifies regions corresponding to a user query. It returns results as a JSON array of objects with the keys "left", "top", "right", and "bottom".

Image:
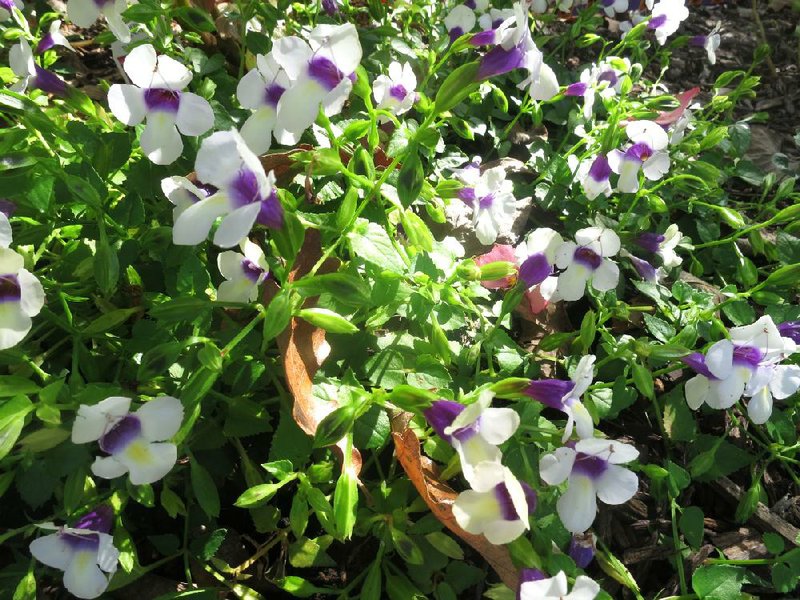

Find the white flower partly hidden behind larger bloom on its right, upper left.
[{"left": 236, "top": 52, "right": 300, "bottom": 154}]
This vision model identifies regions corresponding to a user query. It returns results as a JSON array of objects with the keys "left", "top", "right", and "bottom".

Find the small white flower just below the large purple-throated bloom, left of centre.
[{"left": 217, "top": 238, "right": 269, "bottom": 302}]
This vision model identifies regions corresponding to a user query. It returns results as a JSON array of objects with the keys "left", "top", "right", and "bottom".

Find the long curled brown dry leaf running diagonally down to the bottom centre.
[{"left": 392, "top": 412, "right": 519, "bottom": 590}]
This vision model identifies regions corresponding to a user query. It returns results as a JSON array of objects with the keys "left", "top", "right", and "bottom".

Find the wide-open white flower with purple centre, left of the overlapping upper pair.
[{"left": 111, "top": 44, "right": 214, "bottom": 165}]
